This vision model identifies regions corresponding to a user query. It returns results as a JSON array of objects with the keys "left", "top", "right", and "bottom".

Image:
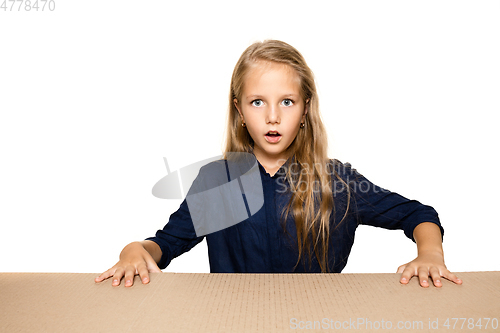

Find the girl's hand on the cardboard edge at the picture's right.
[{"left": 397, "top": 252, "right": 462, "bottom": 288}]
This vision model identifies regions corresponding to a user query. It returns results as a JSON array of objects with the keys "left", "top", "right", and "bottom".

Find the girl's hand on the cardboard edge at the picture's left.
[{"left": 95, "top": 242, "right": 161, "bottom": 287}]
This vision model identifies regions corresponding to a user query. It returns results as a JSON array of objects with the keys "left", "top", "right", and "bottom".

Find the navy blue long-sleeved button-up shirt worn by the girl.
[{"left": 148, "top": 160, "right": 444, "bottom": 273}]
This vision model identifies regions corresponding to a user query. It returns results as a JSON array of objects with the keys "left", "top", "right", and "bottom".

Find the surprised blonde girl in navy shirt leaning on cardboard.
[{"left": 96, "top": 40, "right": 462, "bottom": 287}]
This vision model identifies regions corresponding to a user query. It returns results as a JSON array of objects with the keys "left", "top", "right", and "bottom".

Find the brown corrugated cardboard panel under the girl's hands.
[{"left": 0, "top": 272, "right": 500, "bottom": 332}]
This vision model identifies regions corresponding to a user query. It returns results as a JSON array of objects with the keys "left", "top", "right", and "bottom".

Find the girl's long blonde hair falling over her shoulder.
[{"left": 224, "top": 40, "right": 350, "bottom": 273}]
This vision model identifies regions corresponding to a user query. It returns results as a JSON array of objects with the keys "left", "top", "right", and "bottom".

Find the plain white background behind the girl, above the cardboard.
[{"left": 0, "top": 0, "right": 500, "bottom": 272}]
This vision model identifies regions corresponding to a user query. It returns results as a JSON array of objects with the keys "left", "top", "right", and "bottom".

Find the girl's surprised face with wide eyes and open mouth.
[{"left": 234, "top": 61, "right": 307, "bottom": 168}]
